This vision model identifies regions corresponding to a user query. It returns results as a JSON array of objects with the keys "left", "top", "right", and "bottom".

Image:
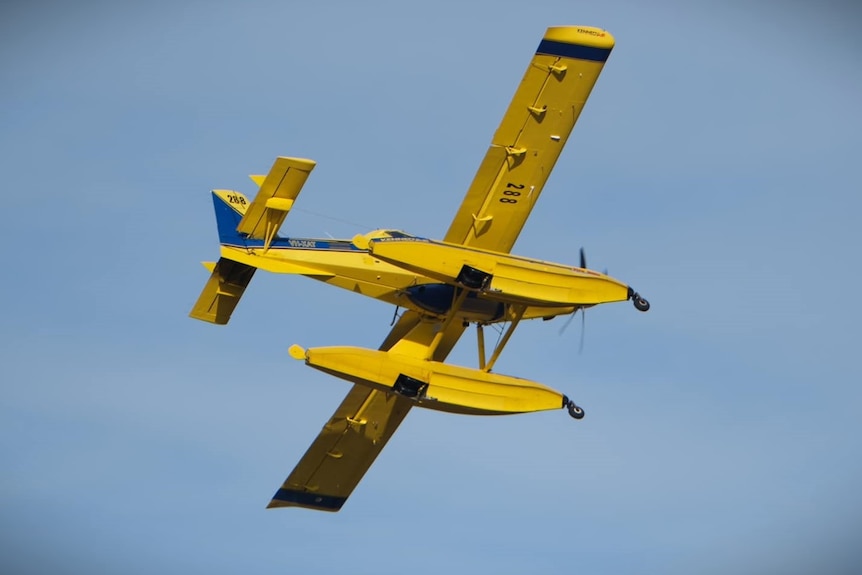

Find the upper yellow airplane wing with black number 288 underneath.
[{"left": 443, "top": 26, "right": 614, "bottom": 253}]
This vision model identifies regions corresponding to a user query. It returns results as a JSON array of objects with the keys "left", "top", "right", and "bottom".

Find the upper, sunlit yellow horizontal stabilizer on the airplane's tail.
[{"left": 236, "top": 157, "right": 316, "bottom": 248}]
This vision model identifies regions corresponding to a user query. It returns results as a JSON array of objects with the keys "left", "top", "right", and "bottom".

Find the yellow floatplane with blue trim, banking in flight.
[{"left": 190, "top": 26, "right": 649, "bottom": 511}]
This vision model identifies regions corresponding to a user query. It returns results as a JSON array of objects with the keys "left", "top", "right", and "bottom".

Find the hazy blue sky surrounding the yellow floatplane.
[{"left": 0, "top": 0, "right": 862, "bottom": 575}]
